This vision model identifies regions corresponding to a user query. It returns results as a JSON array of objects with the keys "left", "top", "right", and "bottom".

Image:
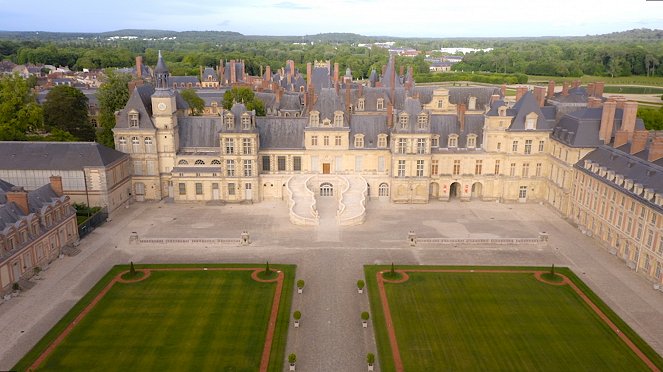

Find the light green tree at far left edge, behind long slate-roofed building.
[{"left": 0, "top": 74, "right": 44, "bottom": 141}]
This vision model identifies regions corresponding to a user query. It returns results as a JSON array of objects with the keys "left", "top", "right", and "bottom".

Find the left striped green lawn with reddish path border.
[{"left": 15, "top": 265, "right": 294, "bottom": 371}]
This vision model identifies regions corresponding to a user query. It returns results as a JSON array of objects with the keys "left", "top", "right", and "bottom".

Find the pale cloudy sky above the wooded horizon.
[{"left": 0, "top": 0, "right": 663, "bottom": 37}]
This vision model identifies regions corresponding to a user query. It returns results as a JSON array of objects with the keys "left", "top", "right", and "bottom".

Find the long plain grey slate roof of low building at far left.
[{"left": 0, "top": 141, "right": 129, "bottom": 170}]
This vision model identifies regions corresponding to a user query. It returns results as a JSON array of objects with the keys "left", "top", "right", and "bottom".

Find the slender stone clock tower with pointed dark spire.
[{"left": 152, "top": 51, "right": 180, "bottom": 198}]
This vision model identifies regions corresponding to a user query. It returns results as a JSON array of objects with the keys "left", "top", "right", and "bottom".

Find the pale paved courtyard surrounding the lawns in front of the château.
[{"left": 0, "top": 201, "right": 663, "bottom": 371}]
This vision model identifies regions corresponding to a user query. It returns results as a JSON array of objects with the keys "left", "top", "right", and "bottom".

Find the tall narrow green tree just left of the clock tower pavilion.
[{"left": 97, "top": 71, "right": 131, "bottom": 147}]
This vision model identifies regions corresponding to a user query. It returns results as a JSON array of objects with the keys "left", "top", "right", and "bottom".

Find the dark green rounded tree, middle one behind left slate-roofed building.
[{"left": 42, "top": 85, "right": 96, "bottom": 141}]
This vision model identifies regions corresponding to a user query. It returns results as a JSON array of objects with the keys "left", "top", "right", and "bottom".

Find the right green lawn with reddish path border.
[{"left": 365, "top": 266, "right": 663, "bottom": 371}]
